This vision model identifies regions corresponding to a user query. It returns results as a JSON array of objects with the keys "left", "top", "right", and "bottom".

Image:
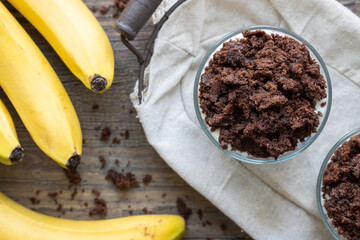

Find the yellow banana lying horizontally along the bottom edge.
[{"left": 0, "top": 192, "right": 185, "bottom": 240}]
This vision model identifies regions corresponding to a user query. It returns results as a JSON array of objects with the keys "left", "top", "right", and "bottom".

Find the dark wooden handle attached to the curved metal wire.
[{"left": 116, "top": 0, "right": 162, "bottom": 40}]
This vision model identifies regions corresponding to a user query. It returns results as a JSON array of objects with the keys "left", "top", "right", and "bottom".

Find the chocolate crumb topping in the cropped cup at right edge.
[{"left": 322, "top": 134, "right": 360, "bottom": 240}]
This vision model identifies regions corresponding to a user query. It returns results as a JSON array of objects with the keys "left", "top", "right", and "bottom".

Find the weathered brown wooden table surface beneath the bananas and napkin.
[{"left": 0, "top": 0, "right": 360, "bottom": 240}]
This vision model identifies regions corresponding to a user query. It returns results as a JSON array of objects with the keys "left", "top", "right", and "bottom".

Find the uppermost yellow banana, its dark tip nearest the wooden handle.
[{"left": 9, "top": 0, "right": 114, "bottom": 92}]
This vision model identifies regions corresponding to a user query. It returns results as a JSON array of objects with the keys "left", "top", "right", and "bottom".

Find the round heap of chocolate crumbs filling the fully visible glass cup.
[{"left": 199, "top": 30, "right": 327, "bottom": 159}]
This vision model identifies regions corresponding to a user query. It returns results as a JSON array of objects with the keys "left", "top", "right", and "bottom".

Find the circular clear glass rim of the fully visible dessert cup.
[{"left": 193, "top": 25, "right": 332, "bottom": 164}]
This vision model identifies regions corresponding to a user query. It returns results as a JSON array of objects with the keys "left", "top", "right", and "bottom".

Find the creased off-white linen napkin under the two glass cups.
[{"left": 131, "top": 0, "right": 360, "bottom": 240}]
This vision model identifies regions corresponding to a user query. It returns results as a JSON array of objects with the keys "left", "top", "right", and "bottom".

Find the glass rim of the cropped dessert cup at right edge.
[{"left": 316, "top": 128, "right": 360, "bottom": 240}]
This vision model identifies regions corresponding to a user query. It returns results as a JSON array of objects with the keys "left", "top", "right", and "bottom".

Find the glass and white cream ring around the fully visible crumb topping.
[{"left": 193, "top": 25, "right": 332, "bottom": 164}]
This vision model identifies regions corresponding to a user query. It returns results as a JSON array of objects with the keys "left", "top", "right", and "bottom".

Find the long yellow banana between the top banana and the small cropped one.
[{"left": 0, "top": 2, "right": 82, "bottom": 168}]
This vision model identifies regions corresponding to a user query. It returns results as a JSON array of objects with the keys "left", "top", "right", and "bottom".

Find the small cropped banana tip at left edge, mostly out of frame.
[{"left": 0, "top": 100, "right": 24, "bottom": 165}]
